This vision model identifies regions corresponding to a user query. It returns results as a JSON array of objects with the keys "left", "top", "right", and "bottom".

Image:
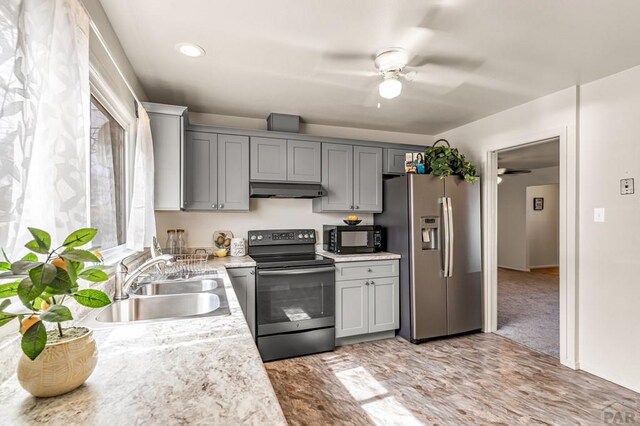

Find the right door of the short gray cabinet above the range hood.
[{"left": 287, "top": 140, "right": 322, "bottom": 183}]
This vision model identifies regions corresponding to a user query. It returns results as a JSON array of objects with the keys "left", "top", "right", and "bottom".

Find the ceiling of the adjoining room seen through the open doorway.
[{"left": 498, "top": 138, "right": 560, "bottom": 170}]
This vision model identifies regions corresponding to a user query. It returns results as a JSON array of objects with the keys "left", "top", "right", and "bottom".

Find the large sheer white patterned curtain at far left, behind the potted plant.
[{"left": 0, "top": 0, "right": 89, "bottom": 260}]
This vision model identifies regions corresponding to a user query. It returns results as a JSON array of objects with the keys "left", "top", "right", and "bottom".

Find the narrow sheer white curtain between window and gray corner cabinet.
[{"left": 127, "top": 105, "right": 156, "bottom": 251}]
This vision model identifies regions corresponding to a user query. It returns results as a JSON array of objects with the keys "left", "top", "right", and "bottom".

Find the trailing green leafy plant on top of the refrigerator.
[{"left": 424, "top": 139, "right": 478, "bottom": 183}]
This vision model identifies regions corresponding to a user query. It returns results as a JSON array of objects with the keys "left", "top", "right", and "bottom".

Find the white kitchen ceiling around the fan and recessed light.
[{"left": 101, "top": 0, "right": 640, "bottom": 134}]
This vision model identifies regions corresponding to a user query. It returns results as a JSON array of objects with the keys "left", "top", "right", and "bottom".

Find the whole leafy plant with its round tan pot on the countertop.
[{"left": 0, "top": 228, "right": 111, "bottom": 397}]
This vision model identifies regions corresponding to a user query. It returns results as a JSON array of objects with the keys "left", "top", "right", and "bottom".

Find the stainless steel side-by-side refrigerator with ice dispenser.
[{"left": 374, "top": 174, "right": 482, "bottom": 343}]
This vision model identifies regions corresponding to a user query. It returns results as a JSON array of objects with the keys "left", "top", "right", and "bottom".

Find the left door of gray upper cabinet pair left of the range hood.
[{"left": 185, "top": 132, "right": 218, "bottom": 210}]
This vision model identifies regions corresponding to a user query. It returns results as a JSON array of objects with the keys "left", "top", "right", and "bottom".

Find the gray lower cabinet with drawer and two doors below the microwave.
[{"left": 336, "top": 260, "right": 400, "bottom": 338}]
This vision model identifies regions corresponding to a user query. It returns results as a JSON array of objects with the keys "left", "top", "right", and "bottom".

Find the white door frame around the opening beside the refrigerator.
[{"left": 482, "top": 125, "right": 579, "bottom": 369}]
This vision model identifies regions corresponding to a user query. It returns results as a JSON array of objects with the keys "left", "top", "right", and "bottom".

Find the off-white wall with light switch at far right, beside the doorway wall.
[{"left": 579, "top": 63, "right": 640, "bottom": 391}]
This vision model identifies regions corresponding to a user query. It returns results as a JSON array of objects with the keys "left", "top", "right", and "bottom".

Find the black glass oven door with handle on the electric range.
[{"left": 256, "top": 266, "right": 335, "bottom": 336}]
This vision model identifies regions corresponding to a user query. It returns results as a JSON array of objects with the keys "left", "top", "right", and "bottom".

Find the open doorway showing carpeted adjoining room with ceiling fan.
[{"left": 496, "top": 137, "right": 560, "bottom": 358}]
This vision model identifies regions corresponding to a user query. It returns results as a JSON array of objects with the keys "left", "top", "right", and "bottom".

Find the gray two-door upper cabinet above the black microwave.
[{"left": 313, "top": 143, "right": 382, "bottom": 213}]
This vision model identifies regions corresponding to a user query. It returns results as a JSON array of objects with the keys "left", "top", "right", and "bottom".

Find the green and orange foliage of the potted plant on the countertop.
[{"left": 0, "top": 228, "right": 111, "bottom": 360}]
